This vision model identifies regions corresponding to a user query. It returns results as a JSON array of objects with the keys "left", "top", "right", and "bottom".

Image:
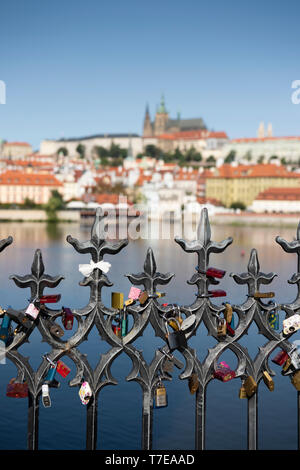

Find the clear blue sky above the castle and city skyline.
[{"left": 0, "top": 0, "right": 300, "bottom": 149}]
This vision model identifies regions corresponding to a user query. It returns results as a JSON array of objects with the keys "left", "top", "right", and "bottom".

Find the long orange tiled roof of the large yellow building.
[{"left": 208, "top": 163, "right": 300, "bottom": 178}]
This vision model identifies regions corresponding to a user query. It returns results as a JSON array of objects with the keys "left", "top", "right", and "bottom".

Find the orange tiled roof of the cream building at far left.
[{"left": 0, "top": 170, "right": 62, "bottom": 186}]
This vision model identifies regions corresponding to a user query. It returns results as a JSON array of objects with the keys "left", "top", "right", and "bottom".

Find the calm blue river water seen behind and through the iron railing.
[{"left": 0, "top": 219, "right": 300, "bottom": 450}]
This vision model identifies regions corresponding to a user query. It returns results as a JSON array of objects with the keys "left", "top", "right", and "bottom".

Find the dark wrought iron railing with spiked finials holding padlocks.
[{"left": 0, "top": 209, "right": 300, "bottom": 450}]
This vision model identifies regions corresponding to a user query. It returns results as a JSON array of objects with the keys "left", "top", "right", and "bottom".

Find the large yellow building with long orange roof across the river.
[{"left": 206, "top": 164, "right": 300, "bottom": 207}]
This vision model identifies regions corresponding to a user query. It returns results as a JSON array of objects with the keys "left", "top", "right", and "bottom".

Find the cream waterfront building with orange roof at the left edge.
[{"left": 0, "top": 170, "right": 62, "bottom": 204}]
